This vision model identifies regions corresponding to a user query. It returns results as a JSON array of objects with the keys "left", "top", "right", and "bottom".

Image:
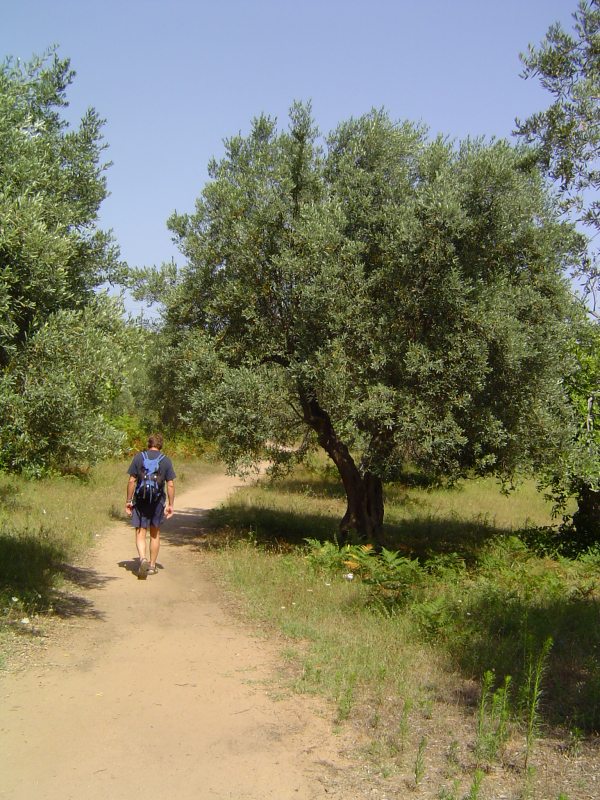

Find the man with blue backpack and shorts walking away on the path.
[{"left": 125, "top": 433, "right": 176, "bottom": 576}]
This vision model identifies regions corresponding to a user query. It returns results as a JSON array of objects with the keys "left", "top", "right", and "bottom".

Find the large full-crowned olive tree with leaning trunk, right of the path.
[{"left": 138, "top": 105, "right": 581, "bottom": 539}]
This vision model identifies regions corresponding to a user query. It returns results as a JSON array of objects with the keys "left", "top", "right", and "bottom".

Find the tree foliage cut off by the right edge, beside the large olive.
[{"left": 516, "top": 0, "right": 600, "bottom": 549}]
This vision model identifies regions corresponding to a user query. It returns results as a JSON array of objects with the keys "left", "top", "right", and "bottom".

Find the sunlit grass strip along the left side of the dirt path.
[{"left": 0, "top": 458, "right": 215, "bottom": 624}]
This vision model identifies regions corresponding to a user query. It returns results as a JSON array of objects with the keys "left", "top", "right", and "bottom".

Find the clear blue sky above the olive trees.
[{"left": 0, "top": 0, "right": 576, "bottom": 310}]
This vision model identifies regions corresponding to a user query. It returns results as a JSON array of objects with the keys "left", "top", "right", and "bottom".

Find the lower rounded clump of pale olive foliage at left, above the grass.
[{"left": 0, "top": 296, "right": 126, "bottom": 475}]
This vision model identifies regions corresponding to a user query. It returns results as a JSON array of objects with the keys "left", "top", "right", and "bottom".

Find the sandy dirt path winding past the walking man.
[{"left": 0, "top": 476, "right": 356, "bottom": 800}]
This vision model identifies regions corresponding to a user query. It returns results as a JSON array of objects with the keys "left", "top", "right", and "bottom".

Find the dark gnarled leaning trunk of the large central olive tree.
[{"left": 299, "top": 388, "right": 383, "bottom": 543}]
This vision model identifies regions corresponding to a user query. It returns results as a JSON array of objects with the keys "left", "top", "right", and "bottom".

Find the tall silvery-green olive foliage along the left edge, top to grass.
[{"left": 0, "top": 50, "right": 122, "bottom": 472}]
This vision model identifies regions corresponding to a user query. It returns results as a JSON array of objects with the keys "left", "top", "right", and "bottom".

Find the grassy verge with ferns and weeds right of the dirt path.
[{"left": 206, "top": 471, "right": 600, "bottom": 800}]
